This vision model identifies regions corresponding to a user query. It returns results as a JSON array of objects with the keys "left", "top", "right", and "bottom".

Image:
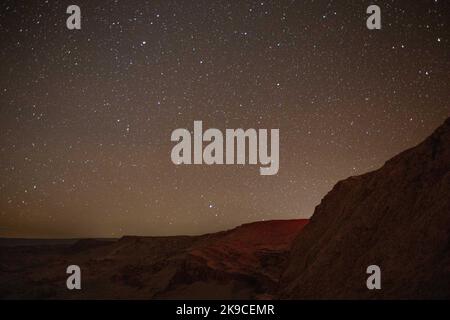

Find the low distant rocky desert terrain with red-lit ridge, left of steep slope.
[{"left": 0, "top": 220, "right": 308, "bottom": 299}]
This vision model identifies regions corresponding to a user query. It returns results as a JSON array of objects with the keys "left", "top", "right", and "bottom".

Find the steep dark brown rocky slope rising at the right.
[{"left": 279, "top": 118, "right": 450, "bottom": 299}]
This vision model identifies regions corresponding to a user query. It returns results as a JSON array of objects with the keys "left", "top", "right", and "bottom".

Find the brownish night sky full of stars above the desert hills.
[{"left": 0, "top": 0, "right": 450, "bottom": 238}]
